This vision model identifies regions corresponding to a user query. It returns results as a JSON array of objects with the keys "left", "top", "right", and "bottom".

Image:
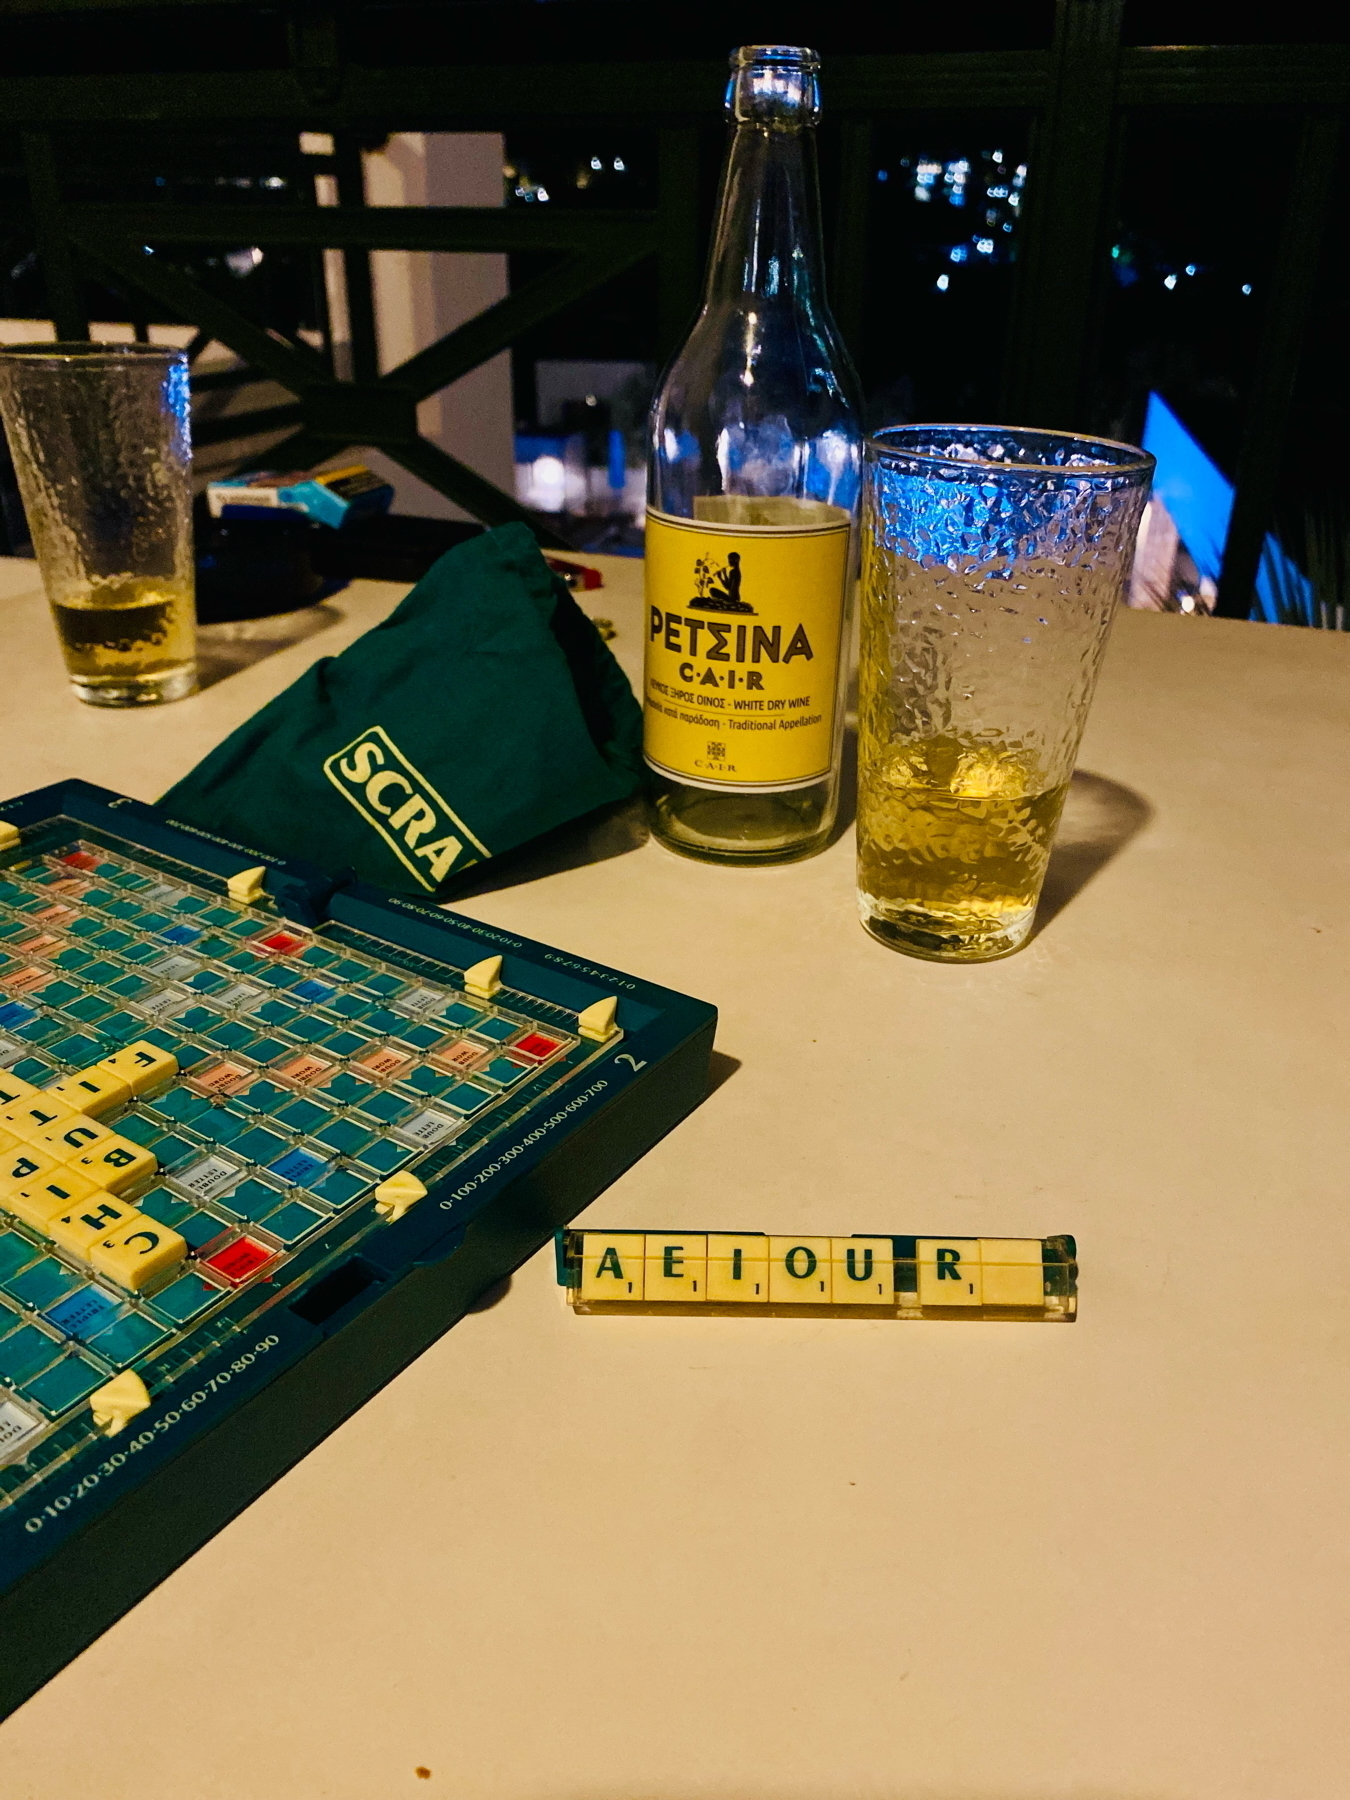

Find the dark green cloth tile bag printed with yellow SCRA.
[{"left": 158, "top": 526, "right": 643, "bottom": 896}]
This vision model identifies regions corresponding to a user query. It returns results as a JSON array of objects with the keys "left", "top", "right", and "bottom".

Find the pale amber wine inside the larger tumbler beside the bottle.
[{"left": 859, "top": 722, "right": 1069, "bottom": 961}]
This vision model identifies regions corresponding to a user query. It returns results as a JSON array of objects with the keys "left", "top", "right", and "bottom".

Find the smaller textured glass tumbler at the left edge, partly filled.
[{"left": 0, "top": 344, "right": 196, "bottom": 706}]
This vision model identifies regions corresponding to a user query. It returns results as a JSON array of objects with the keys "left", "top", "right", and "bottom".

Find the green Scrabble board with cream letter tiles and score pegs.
[{"left": 0, "top": 781, "right": 715, "bottom": 1714}]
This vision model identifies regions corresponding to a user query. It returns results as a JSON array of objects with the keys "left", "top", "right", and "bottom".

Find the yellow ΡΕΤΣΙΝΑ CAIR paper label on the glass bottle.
[{"left": 643, "top": 495, "right": 850, "bottom": 792}]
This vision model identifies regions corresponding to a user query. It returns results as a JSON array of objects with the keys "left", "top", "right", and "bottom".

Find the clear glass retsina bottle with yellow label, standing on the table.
[{"left": 643, "top": 45, "right": 860, "bottom": 864}]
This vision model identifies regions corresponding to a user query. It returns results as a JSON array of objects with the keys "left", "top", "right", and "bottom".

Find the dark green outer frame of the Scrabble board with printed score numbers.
[{"left": 0, "top": 781, "right": 716, "bottom": 1717}]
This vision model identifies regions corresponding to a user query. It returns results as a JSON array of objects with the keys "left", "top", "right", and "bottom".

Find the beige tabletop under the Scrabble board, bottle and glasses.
[{"left": 0, "top": 562, "right": 1350, "bottom": 1800}]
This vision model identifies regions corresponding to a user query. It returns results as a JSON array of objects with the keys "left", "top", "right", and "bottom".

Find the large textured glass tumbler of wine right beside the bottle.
[{"left": 859, "top": 425, "right": 1154, "bottom": 963}]
